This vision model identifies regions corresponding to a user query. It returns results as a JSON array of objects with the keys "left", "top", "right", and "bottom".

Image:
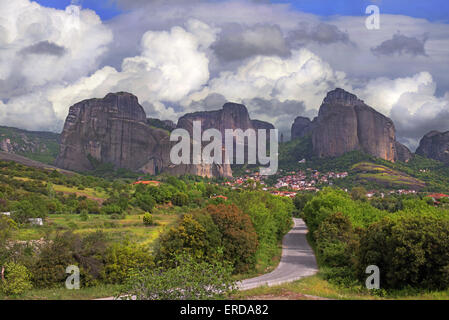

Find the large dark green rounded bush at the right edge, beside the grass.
[{"left": 358, "top": 215, "right": 449, "bottom": 290}]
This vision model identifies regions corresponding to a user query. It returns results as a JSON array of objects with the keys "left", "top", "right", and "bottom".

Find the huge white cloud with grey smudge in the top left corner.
[{"left": 0, "top": 0, "right": 112, "bottom": 98}]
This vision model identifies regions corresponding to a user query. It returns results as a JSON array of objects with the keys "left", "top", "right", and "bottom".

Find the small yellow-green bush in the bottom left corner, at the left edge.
[{"left": 1, "top": 262, "right": 33, "bottom": 296}]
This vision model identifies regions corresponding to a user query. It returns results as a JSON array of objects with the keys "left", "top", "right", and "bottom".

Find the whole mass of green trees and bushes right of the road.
[{"left": 295, "top": 188, "right": 449, "bottom": 290}]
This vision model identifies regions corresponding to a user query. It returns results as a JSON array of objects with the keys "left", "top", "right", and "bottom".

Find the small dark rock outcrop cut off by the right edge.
[{"left": 416, "top": 131, "right": 449, "bottom": 164}]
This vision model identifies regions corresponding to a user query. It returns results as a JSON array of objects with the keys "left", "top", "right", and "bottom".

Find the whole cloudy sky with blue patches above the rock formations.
[{"left": 0, "top": 0, "right": 449, "bottom": 150}]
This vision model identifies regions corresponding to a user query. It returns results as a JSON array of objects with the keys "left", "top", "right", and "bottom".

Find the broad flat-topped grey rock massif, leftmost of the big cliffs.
[{"left": 56, "top": 92, "right": 229, "bottom": 177}]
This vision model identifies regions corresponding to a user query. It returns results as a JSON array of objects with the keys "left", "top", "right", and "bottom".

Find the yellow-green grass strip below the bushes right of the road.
[{"left": 234, "top": 274, "right": 449, "bottom": 300}]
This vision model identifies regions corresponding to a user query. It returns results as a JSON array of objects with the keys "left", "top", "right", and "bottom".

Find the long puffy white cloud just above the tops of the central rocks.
[{"left": 184, "top": 49, "right": 345, "bottom": 109}]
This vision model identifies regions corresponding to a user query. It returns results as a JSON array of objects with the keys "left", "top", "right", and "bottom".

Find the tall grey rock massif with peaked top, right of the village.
[{"left": 292, "top": 89, "right": 411, "bottom": 161}]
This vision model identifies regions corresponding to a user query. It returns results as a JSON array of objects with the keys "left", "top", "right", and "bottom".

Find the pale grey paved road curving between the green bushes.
[{"left": 238, "top": 219, "right": 318, "bottom": 290}]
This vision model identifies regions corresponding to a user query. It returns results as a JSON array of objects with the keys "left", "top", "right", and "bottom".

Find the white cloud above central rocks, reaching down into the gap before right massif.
[{"left": 181, "top": 49, "right": 349, "bottom": 134}]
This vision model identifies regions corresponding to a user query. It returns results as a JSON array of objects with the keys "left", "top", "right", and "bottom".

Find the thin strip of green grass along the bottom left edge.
[{"left": 0, "top": 284, "right": 119, "bottom": 300}]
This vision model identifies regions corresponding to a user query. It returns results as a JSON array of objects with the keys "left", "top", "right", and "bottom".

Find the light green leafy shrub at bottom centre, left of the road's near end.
[{"left": 118, "top": 255, "right": 235, "bottom": 300}]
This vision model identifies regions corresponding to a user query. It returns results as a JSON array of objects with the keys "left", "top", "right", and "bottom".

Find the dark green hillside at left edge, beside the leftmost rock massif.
[{"left": 0, "top": 126, "right": 59, "bottom": 164}]
